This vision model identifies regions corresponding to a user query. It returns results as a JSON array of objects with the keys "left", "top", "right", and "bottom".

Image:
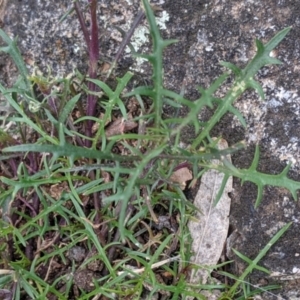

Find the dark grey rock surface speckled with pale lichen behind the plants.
[{"left": 0, "top": 0, "right": 300, "bottom": 299}]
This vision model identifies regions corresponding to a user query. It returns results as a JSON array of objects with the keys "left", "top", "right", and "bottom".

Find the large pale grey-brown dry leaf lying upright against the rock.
[{"left": 188, "top": 139, "right": 232, "bottom": 300}]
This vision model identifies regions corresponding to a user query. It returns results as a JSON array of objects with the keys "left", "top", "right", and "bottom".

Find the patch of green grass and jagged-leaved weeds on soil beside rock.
[{"left": 0, "top": 0, "right": 300, "bottom": 299}]
